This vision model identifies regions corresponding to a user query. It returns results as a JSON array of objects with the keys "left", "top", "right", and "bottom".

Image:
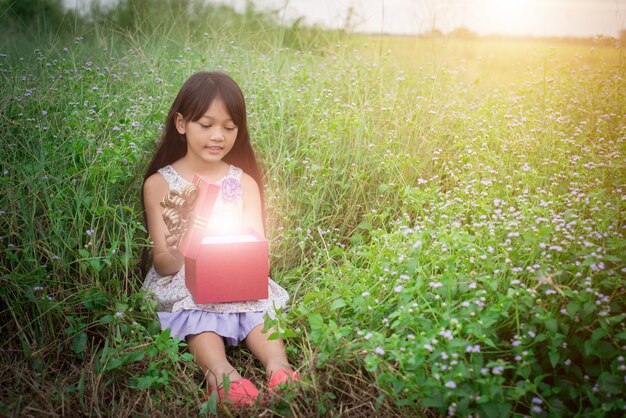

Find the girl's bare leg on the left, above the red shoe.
[{"left": 187, "top": 332, "right": 241, "bottom": 388}]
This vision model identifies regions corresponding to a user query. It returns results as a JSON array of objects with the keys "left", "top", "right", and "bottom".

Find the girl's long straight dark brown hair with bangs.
[{"left": 140, "top": 71, "right": 265, "bottom": 276}]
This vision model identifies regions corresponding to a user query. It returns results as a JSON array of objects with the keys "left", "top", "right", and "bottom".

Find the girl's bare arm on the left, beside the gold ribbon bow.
[{"left": 143, "top": 173, "right": 184, "bottom": 276}]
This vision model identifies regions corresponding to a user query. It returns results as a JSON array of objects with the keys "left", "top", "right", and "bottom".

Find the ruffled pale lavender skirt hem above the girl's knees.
[{"left": 157, "top": 309, "right": 265, "bottom": 346}]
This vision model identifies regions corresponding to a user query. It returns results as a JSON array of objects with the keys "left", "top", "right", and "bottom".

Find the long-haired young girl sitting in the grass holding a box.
[{"left": 143, "top": 72, "right": 298, "bottom": 405}]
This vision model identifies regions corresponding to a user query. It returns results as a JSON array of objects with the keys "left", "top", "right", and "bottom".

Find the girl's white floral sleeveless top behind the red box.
[{"left": 142, "top": 165, "right": 289, "bottom": 313}]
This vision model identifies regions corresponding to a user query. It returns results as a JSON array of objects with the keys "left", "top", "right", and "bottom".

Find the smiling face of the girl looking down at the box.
[{"left": 176, "top": 98, "right": 238, "bottom": 162}]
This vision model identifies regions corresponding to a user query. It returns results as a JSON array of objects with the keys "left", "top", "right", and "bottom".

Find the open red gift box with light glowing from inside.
[{"left": 179, "top": 175, "right": 269, "bottom": 304}]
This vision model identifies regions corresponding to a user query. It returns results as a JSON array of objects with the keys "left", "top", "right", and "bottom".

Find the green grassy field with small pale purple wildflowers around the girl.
[{"left": 0, "top": 1, "right": 626, "bottom": 417}]
